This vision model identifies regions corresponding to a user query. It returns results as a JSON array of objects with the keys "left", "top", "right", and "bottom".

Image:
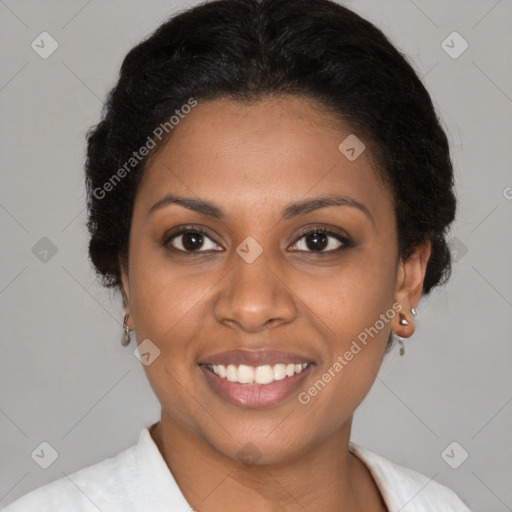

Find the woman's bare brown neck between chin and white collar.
[{"left": 147, "top": 412, "right": 387, "bottom": 512}]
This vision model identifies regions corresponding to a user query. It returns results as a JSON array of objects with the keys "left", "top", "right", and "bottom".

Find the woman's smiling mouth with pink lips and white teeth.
[{"left": 199, "top": 350, "right": 314, "bottom": 409}]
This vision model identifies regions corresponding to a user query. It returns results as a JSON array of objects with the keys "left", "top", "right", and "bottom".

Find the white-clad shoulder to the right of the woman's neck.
[{"left": 350, "top": 443, "right": 471, "bottom": 512}]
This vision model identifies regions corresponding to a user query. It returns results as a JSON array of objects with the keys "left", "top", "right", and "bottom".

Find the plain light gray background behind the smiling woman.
[{"left": 0, "top": 0, "right": 512, "bottom": 512}]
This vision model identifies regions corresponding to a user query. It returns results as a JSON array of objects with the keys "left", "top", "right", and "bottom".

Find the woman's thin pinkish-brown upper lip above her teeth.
[{"left": 199, "top": 349, "right": 311, "bottom": 366}]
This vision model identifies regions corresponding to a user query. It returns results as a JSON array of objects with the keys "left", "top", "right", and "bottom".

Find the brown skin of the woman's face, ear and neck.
[{"left": 122, "top": 96, "right": 430, "bottom": 512}]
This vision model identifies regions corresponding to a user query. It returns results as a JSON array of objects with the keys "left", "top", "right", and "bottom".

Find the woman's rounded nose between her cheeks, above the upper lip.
[{"left": 214, "top": 251, "right": 297, "bottom": 333}]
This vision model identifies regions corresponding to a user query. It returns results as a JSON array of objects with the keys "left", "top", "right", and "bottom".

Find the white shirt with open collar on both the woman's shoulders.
[{"left": 3, "top": 427, "right": 471, "bottom": 512}]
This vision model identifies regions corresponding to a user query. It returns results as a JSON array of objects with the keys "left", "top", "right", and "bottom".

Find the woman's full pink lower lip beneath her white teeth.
[{"left": 199, "top": 364, "right": 311, "bottom": 409}]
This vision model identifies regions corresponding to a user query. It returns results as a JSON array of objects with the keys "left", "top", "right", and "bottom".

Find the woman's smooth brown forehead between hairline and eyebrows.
[{"left": 137, "top": 96, "right": 392, "bottom": 223}]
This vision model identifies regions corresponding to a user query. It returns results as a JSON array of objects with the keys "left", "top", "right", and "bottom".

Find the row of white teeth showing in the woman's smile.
[{"left": 209, "top": 363, "right": 308, "bottom": 384}]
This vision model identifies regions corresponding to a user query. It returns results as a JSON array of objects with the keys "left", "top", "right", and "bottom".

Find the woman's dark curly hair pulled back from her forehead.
[{"left": 86, "top": 0, "right": 456, "bottom": 320}]
